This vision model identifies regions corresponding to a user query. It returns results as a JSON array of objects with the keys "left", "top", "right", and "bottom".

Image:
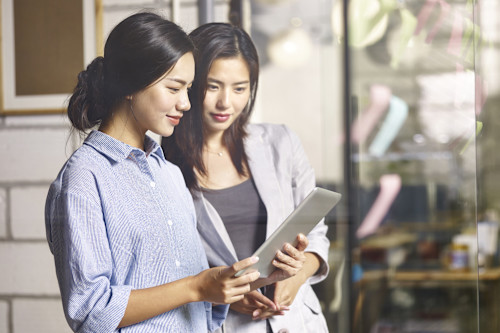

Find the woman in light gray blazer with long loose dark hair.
[{"left": 162, "top": 23, "right": 329, "bottom": 333}]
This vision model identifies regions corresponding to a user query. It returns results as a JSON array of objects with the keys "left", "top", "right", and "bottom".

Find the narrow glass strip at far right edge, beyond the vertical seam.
[{"left": 475, "top": 0, "right": 500, "bottom": 332}]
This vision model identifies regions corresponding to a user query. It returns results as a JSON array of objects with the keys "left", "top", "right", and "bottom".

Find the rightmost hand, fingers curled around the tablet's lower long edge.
[{"left": 267, "top": 234, "right": 309, "bottom": 284}]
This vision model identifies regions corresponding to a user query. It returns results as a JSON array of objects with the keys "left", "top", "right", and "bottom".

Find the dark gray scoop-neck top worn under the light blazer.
[{"left": 203, "top": 179, "right": 267, "bottom": 260}]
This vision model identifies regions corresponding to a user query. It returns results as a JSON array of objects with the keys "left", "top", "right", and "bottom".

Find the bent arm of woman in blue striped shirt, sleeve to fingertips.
[{"left": 46, "top": 180, "right": 258, "bottom": 332}]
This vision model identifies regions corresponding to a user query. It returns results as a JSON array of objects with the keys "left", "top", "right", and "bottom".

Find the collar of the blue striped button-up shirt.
[{"left": 84, "top": 130, "right": 166, "bottom": 162}]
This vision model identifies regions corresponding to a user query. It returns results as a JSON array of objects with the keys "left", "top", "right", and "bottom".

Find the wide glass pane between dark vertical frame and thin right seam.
[{"left": 347, "top": 0, "right": 482, "bottom": 332}]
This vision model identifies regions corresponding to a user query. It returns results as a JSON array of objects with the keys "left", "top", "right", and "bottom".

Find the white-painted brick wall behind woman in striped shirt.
[{"left": 0, "top": 0, "right": 229, "bottom": 333}]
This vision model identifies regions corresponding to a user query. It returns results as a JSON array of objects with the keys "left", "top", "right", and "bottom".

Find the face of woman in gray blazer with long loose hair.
[{"left": 203, "top": 57, "right": 250, "bottom": 134}]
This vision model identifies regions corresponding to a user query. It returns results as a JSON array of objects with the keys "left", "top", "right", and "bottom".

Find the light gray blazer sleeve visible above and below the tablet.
[{"left": 284, "top": 126, "right": 330, "bottom": 284}]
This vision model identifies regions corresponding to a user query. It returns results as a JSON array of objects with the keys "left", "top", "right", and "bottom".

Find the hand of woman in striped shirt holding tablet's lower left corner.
[{"left": 195, "top": 257, "right": 260, "bottom": 304}]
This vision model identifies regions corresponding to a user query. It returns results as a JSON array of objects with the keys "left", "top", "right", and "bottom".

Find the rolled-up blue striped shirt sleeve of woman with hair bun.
[{"left": 45, "top": 172, "right": 132, "bottom": 332}]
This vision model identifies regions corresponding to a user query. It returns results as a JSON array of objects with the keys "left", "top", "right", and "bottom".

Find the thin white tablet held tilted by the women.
[{"left": 235, "top": 187, "right": 342, "bottom": 277}]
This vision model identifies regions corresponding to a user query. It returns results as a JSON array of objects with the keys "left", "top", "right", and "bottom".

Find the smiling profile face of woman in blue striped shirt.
[{"left": 132, "top": 53, "right": 194, "bottom": 136}]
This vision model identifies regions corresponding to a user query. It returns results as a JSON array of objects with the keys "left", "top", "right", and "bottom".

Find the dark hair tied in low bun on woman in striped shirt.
[{"left": 68, "top": 12, "right": 194, "bottom": 132}]
